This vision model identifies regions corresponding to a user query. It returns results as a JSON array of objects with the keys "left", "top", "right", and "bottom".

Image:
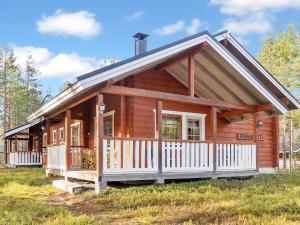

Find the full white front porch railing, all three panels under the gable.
[{"left": 103, "top": 138, "right": 256, "bottom": 174}]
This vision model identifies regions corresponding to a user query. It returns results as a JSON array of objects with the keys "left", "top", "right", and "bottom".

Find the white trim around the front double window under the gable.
[{"left": 153, "top": 109, "right": 207, "bottom": 141}]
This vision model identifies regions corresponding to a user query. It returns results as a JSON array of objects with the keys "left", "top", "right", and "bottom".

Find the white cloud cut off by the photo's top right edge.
[{"left": 210, "top": 0, "right": 300, "bottom": 15}]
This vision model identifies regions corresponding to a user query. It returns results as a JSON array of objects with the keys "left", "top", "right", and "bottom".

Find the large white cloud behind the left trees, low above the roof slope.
[{"left": 13, "top": 46, "right": 115, "bottom": 80}]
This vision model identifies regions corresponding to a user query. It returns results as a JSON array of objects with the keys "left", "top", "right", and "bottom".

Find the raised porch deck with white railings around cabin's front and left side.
[{"left": 47, "top": 138, "right": 258, "bottom": 182}]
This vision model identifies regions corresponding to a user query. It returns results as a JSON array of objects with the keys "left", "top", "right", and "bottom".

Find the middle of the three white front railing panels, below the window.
[{"left": 162, "top": 140, "right": 213, "bottom": 172}]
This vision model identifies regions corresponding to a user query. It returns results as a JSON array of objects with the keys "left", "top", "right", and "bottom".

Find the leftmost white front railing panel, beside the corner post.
[{"left": 103, "top": 138, "right": 158, "bottom": 174}]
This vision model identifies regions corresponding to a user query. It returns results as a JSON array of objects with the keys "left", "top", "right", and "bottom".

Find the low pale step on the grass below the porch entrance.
[{"left": 52, "top": 180, "right": 93, "bottom": 194}]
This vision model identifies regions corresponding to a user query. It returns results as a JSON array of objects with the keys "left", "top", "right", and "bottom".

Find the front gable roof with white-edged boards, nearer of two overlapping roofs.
[{"left": 28, "top": 31, "right": 298, "bottom": 121}]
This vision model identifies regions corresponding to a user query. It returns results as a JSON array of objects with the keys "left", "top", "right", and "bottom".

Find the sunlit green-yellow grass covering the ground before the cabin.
[{"left": 0, "top": 169, "right": 300, "bottom": 225}]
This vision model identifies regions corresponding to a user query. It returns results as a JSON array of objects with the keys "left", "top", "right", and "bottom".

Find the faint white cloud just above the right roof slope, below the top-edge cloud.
[{"left": 223, "top": 13, "right": 272, "bottom": 36}]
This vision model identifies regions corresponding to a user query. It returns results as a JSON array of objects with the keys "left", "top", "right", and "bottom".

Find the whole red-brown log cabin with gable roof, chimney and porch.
[{"left": 3, "top": 31, "right": 300, "bottom": 192}]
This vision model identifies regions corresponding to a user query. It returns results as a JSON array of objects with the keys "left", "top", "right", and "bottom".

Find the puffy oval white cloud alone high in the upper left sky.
[{"left": 37, "top": 9, "right": 101, "bottom": 39}]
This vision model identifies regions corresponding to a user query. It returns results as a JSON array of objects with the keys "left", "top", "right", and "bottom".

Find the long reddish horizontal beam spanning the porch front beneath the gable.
[{"left": 101, "top": 85, "right": 256, "bottom": 110}]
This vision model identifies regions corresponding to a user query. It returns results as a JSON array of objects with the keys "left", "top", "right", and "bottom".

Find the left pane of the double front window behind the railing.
[{"left": 162, "top": 114, "right": 182, "bottom": 139}]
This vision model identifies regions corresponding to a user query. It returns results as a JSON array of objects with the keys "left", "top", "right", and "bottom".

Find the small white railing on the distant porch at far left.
[{"left": 9, "top": 152, "right": 42, "bottom": 166}]
